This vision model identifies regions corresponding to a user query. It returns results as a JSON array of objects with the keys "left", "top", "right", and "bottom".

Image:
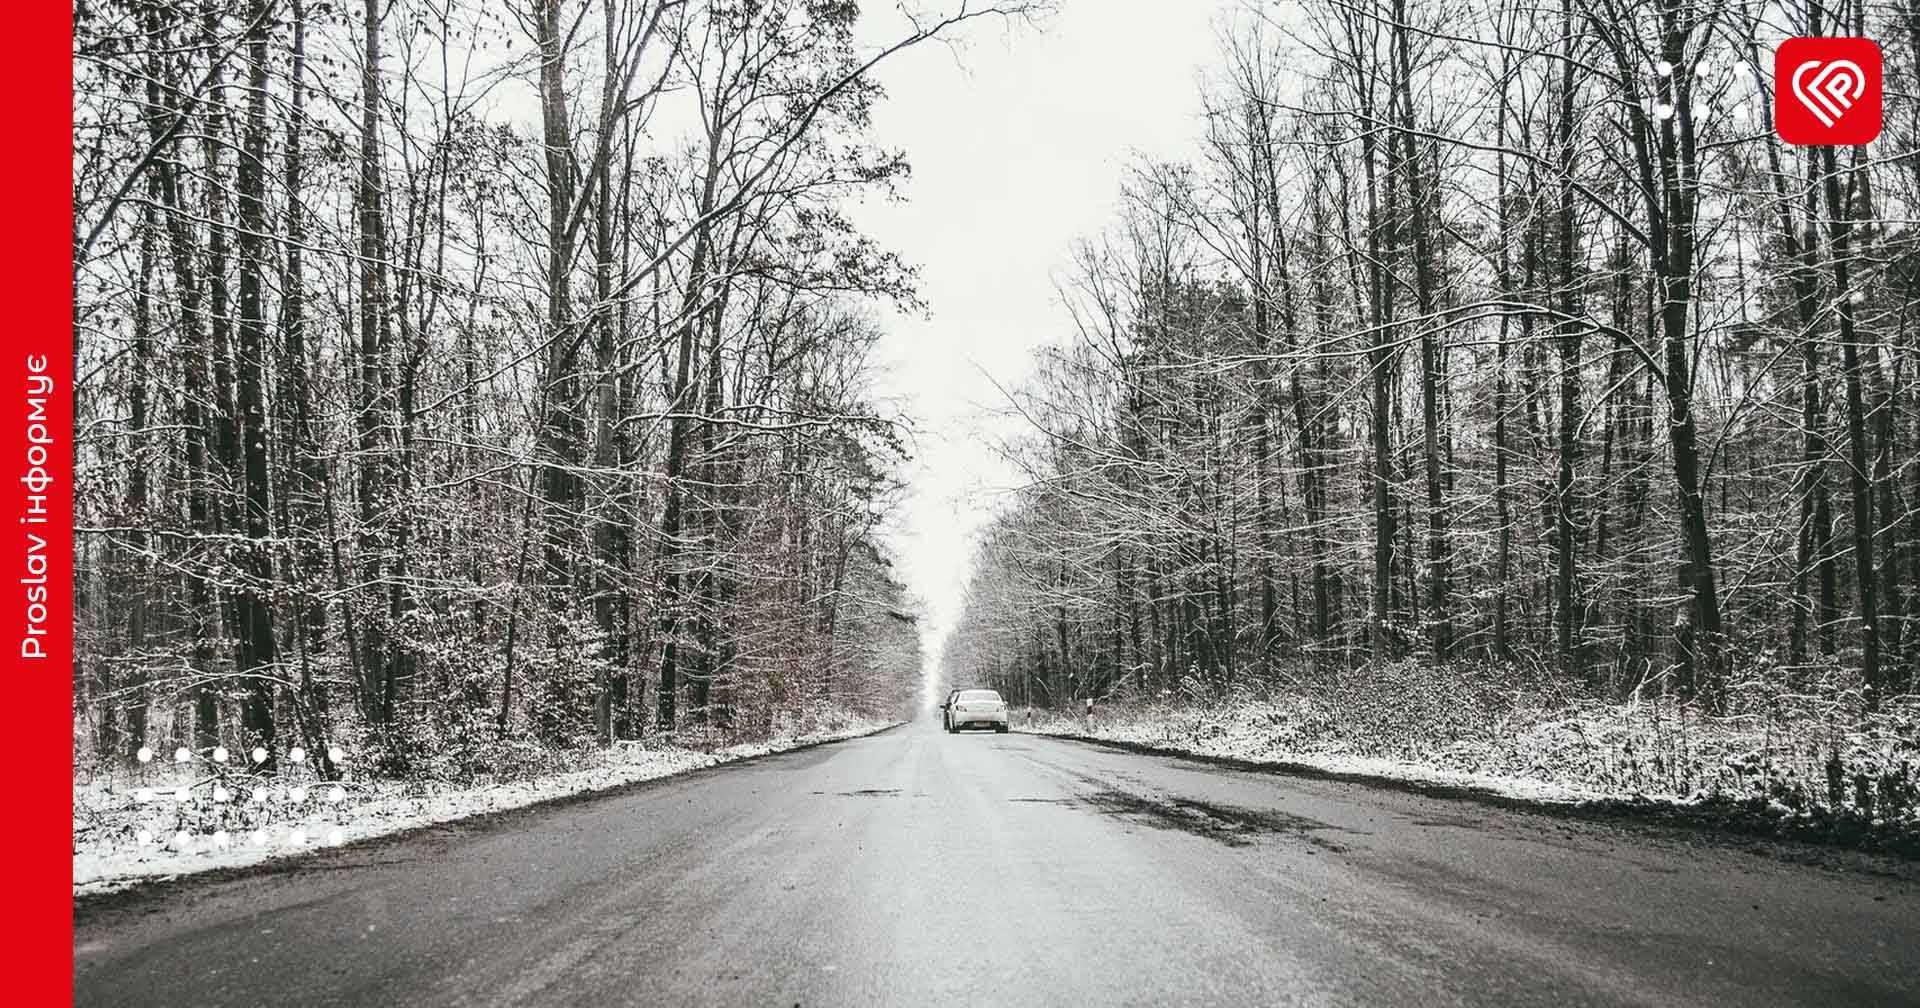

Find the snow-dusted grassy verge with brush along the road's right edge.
[{"left": 1014, "top": 662, "right": 1920, "bottom": 852}]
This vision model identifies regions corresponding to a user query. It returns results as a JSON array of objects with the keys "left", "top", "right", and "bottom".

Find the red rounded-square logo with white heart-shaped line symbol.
[{"left": 1774, "top": 38, "right": 1882, "bottom": 146}]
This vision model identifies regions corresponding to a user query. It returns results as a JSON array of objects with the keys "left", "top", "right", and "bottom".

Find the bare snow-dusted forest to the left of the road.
[{"left": 73, "top": 0, "right": 1021, "bottom": 776}]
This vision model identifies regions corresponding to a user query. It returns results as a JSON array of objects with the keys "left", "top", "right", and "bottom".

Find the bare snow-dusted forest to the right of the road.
[{"left": 943, "top": 0, "right": 1920, "bottom": 741}]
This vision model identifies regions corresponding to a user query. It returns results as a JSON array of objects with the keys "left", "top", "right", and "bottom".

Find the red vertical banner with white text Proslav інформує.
[{"left": 0, "top": 2, "right": 79, "bottom": 1004}]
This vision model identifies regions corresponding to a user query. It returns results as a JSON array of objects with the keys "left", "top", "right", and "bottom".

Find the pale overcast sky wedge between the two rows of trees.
[{"left": 854, "top": 0, "right": 1235, "bottom": 691}]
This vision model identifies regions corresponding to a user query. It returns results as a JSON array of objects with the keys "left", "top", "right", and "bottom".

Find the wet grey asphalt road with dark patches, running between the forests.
[{"left": 73, "top": 722, "right": 1920, "bottom": 1008}]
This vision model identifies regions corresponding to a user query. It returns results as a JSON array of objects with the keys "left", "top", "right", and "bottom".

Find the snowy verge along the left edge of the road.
[{"left": 73, "top": 720, "right": 899, "bottom": 899}]
